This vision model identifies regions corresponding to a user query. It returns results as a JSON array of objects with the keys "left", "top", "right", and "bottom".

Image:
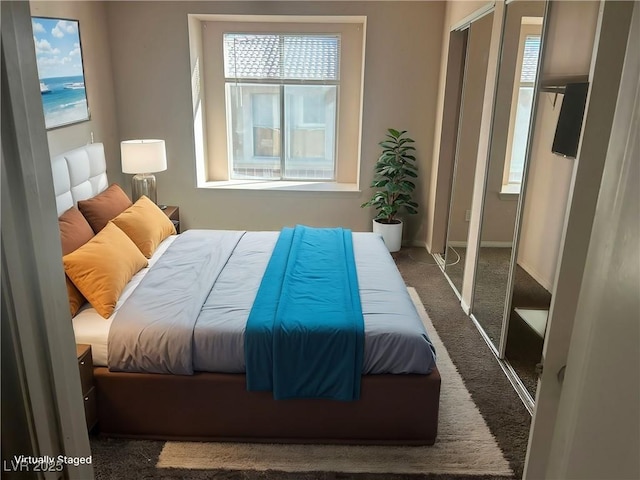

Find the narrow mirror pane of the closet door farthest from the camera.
[{"left": 444, "top": 12, "right": 494, "bottom": 292}]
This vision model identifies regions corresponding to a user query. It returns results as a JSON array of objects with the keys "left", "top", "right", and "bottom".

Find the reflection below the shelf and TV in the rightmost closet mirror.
[{"left": 505, "top": 85, "right": 575, "bottom": 398}]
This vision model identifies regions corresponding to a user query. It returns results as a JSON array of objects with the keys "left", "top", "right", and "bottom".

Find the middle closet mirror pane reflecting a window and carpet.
[{"left": 472, "top": 1, "right": 545, "bottom": 351}]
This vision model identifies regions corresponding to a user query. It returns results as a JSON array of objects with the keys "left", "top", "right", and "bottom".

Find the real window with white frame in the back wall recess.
[{"left": 224, "top": 33, "right": 340, "bottom": 180}]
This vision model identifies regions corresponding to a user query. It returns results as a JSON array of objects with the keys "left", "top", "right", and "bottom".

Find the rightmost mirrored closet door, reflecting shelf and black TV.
[{"left": 500, "top": 2, "right": 599, "bottom": 403}]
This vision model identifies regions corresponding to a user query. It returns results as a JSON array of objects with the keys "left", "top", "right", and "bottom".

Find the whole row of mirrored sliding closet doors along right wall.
[{"left": 441, "top": 0, "right": 599, "bottom": 411}]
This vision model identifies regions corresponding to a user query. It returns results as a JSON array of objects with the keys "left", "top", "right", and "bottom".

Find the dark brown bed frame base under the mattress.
[{"left": 94, "top": 367, "right": 440, "bottom": 445}]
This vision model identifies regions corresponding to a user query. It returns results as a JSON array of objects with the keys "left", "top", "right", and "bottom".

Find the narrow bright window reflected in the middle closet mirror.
[{"left": 502, "top": 25, "right": 540, "bottom": 193}]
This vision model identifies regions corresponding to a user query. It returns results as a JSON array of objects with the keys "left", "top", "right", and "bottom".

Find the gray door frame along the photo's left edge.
[{"left": 1, "top": 2, "right": 93, "bottom": 479}]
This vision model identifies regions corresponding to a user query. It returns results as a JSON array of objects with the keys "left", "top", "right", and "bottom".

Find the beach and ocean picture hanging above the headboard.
[{"left": 31, "top": 17, "right": 90, "bottom": 130}]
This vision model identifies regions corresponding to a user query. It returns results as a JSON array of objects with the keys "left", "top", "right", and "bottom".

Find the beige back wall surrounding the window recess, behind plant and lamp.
[{"left": 106, "top": 2, "right": 444, "bottom": 241}]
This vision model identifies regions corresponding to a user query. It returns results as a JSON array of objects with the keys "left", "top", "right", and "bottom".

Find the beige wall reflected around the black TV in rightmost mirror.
[{"left": 518, "top": 2, "right": 599, "bottom": 291}]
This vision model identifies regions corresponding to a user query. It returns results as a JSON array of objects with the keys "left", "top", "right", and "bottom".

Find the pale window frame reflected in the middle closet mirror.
[{"left": 500, "top": 22, "right": 542, "bottom": 195}]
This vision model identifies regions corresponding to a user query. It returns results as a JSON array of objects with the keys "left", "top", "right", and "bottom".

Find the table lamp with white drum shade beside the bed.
[{"left": 120, "top": 139, "right": 167, "bottom": 204}]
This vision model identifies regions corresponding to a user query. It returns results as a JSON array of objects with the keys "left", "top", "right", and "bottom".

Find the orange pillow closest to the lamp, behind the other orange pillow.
[{"left": 112, "top": 195, "right": 176, "bottom": 258}]
